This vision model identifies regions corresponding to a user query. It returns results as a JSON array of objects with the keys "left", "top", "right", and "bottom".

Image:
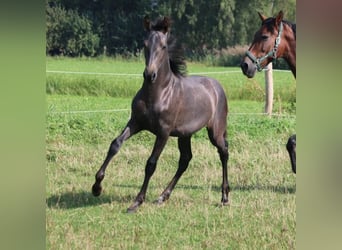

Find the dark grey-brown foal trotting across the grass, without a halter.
[{"left": 92, "top": 17, "right": 230, "bottom": 212}]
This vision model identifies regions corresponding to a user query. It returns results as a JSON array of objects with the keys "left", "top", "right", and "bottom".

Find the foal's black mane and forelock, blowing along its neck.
[{"left": 151, "top": 18, "right": 187, "bottom": 76}]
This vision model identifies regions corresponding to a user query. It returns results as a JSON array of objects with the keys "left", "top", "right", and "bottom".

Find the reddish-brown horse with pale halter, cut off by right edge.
[{"left": 241, "top": 11, "right": 296, "bottom": 173}]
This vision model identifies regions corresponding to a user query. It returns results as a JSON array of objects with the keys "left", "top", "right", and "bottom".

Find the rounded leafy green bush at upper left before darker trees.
[{"left": 46, "top": 2, "right": 100, "bottom": 56}]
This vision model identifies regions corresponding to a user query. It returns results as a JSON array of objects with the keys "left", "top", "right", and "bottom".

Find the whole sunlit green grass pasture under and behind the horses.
[{"left": 46, "top": 58, "right": 296, "bottom": 249}]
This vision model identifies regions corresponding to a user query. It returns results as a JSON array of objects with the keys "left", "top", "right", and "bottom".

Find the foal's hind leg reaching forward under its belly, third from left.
[{"left": 157, "top": 137, "right": 192, "bottom": 204}]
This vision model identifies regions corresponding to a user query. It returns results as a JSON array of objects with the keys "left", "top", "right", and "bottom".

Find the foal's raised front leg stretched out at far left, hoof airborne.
[{"left": 92, "top": 120, "right": 140, "bottom": 196}]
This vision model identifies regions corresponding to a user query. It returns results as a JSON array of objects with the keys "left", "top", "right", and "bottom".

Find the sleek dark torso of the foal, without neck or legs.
[{"left": 133, "top": 79, "right": 216, "bottom": 136}]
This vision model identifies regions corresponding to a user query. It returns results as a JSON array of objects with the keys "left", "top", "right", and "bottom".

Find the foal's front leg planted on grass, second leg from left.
[{"left": 127, "top": 135, "right": 168, "bottom": 213}]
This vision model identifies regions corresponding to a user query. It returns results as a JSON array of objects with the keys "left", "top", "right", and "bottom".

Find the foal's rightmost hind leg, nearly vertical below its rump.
[{"left": 208, "top": 129, "right": 230, "bottom": 205}]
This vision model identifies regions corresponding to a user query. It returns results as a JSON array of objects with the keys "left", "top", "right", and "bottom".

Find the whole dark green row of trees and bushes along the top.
[{"left": 46, "top": 0, "right": 296, "bottom": 60}]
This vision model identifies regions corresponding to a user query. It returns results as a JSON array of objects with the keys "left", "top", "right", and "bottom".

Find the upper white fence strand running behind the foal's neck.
[{"left": 46, "top": 69, "right": 291, "bottom": 77}]
